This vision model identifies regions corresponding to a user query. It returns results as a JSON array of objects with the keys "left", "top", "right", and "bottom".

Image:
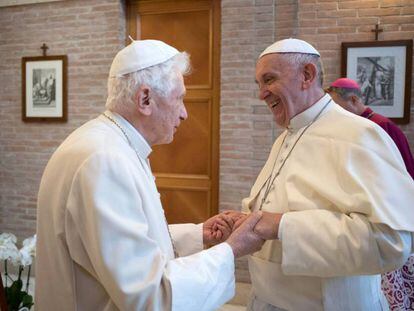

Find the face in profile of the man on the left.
[{"left": 152, "top": 74, "right": 187, "bottom": 145}]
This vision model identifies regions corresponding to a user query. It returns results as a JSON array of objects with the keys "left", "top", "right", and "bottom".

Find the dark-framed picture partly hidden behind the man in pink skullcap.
[{"left": 341, "top": 40, "right": 413, "bottom": 124}]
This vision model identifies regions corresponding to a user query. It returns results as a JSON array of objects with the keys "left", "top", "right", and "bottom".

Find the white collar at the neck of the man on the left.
[{"left": 104, "top": 110, "right": 152, "bottom": 159}]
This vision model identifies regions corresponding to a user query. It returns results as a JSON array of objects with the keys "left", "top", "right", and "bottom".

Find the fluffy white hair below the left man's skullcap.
[{"left": 105, "top": 52, "right": 191, "bottom": 111}]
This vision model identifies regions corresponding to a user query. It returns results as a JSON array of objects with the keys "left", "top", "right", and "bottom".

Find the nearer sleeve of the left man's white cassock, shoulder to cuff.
[{"left": 65, "top": 153, "right": 235, "bottom": 311}]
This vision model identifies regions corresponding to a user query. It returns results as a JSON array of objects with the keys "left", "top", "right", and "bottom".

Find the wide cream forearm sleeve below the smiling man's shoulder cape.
[{"left": 282, "top": 210, "right": 412, "bottom": 277}]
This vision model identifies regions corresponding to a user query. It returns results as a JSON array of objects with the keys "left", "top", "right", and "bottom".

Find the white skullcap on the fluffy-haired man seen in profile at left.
[{"left": 109, "top": 40, "right": 180, "bottom": 78}]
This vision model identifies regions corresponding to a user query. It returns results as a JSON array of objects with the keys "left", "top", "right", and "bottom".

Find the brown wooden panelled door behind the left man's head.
[{"left": 127, "top": 0, "right": 220, "bottom": 223}]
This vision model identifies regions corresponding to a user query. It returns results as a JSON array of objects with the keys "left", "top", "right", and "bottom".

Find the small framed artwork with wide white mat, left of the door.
[{"left": 22, "top": 55, "right": 67, "bottom": 122}]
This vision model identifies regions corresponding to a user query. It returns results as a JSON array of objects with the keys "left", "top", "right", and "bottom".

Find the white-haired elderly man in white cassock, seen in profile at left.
[{"left": 35, "top": 40, "right": 264, "bottom": 311}]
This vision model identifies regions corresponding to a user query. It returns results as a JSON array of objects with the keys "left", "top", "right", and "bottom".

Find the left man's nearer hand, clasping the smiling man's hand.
[{"left": 226, "top": 212, "right": 265, "bottom": 258}]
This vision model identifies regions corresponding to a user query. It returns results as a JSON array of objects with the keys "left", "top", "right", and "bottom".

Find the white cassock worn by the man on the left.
[{"left": 35, "top": 111, "right": 235, "bottom": 311}]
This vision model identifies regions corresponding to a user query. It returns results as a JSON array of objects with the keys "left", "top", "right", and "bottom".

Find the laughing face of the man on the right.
[{"left": 256, "top": 53, "right": 302, "bottom": 127}]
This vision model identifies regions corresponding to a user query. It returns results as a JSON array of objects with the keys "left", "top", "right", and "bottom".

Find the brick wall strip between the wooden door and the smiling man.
[{"left": 219, "top": 0, "right": 275, "bottom": 282}]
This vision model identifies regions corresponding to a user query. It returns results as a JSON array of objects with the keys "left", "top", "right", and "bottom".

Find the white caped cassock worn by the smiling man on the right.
[{"left": 243, "top": 95, "right": 414, "bottom": 311}]
